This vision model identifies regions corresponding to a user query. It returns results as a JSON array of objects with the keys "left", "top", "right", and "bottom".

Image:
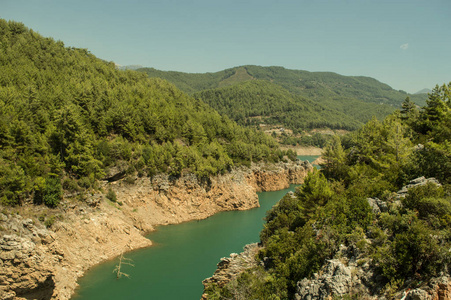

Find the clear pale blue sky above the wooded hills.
[{"left": 0, "top": 0, "right": 451, "bottom": 92}]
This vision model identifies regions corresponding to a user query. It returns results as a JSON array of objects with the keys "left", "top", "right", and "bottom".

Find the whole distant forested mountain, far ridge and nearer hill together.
[{"left": 138, "top": 66, "right": 427, "bottom": 129}]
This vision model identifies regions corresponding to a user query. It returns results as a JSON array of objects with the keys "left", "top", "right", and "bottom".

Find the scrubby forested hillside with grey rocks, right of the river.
[{"left": 206, "top": 83, "right": 451, "bottom": 299}]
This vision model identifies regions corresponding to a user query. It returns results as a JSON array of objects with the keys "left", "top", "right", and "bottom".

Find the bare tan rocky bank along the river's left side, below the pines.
[{"left": 0, "top": 161, "right": 312, "bottom": 300}]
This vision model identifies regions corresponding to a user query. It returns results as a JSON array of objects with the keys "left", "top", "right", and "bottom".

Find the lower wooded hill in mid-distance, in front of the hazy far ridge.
[{"left": 194, "top": 80, "right": 363, "bottom": 131}]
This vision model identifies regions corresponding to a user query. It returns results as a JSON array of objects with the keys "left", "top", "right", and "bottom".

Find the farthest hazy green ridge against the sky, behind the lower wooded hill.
[{"left": 140, "top": 66, "right": 427, "bottom": 123}]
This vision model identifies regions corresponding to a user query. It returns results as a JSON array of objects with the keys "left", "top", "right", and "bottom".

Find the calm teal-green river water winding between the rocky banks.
[{"left": 72, "top": 156, "right": 316, "bottom": 300}]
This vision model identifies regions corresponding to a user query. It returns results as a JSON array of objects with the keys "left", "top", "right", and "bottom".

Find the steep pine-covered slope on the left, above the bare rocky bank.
[{"left": 0, "top": 20, "right": 290, "bottom": 206}]
